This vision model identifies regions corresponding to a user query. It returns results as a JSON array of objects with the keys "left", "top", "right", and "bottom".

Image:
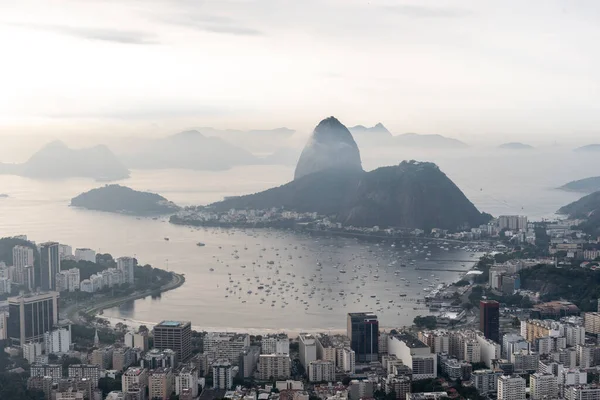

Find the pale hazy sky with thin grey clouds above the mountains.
[{"left": 0, "top": 0, "right": 600, "bottom": 139}]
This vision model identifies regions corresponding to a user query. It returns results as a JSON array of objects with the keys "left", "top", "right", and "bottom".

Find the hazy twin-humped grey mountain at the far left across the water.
[{"left": 0, "top": 140, "right": 129, "bottom": 181}]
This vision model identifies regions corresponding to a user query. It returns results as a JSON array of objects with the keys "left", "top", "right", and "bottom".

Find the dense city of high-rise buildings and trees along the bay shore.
[{"left": 0, "top": 211, "right": 600, "bottom": 400}]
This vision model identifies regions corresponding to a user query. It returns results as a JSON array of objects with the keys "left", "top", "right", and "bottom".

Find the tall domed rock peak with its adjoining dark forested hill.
[{"left": 208, "top": 117, "right": 489, "bottom": 230}]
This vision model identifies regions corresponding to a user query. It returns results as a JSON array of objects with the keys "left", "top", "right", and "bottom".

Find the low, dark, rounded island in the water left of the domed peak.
[{"left": 71, "top": 185, "right": 179, "bottom": 216}]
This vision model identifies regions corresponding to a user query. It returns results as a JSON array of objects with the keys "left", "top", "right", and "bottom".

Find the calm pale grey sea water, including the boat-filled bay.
[{"left": 0, "top": 149, "right": 600, "bottom": 331}]
